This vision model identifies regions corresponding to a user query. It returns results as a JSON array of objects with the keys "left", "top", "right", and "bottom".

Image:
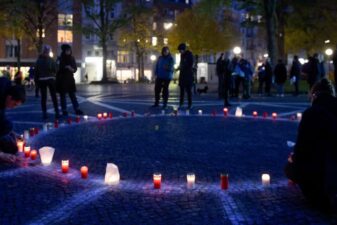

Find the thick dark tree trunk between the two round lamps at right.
[{"left": 263, "top": 0, "right": 277, "bottom": 68}]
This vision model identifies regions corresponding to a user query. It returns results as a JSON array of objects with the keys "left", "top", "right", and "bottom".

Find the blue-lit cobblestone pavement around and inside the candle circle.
[{"left": 0, "top": 85, "right": 337, "bottom": 225}]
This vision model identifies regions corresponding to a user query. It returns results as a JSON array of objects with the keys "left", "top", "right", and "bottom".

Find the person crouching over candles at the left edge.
[{"left": 0, "top": 77, "right": 26, "bottom": 154}]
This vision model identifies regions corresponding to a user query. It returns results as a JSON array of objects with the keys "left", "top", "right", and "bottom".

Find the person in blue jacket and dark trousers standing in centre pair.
[{"left": 153, "top": 47, "right": 174, "bottom": 109}]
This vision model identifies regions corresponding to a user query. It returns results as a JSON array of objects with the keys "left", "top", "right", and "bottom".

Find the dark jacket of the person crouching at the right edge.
[{"left": 292, "top": 95, "right": 337, "bottom": 200}]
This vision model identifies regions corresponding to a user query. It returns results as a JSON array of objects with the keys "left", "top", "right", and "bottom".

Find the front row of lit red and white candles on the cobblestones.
[{"left": 18, "top": 143, "right": 270, "bottom": 190}]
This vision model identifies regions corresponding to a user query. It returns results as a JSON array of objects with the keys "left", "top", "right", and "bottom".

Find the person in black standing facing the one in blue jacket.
[{"left": 178, "top": 43, "right": 193, "bottom": 109}]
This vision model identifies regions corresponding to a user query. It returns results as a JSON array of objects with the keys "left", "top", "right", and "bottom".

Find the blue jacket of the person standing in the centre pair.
[{"left": 155, "top": 55, "right": 174, "bottom": 80}]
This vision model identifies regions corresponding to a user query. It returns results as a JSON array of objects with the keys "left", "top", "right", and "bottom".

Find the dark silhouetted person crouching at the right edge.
[{"left": 285, "top": 78, "right": 337, "bottom": 209}]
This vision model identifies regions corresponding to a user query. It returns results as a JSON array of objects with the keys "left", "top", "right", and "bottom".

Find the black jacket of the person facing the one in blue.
[{"left": 179, "top": 50, "right": 194, "bottom": 87}]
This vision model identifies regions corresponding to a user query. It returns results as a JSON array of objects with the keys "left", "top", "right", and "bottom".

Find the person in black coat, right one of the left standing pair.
[{"left": 56, "top": 44, "right": 83, "bottom": 116}]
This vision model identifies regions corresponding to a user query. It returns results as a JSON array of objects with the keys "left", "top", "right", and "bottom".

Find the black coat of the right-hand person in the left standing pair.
[{"left": 56, "top": 54, "right": 77, "bottom": 93}]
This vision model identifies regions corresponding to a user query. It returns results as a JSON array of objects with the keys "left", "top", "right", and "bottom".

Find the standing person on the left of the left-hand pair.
[{"left": 35, "top": 45, "right": 60, "bottom": 119}]
